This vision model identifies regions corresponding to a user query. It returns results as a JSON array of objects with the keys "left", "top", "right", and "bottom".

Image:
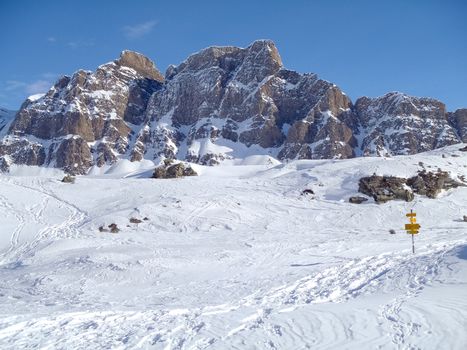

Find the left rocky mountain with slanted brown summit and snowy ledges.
[{"left": 0, "top": 51, "right": 163, "bottom": 174}]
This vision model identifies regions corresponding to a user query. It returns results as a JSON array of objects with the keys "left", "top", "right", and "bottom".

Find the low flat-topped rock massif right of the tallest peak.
[{"left": 355, "top": 93, "right": 461, "bottom": 156}]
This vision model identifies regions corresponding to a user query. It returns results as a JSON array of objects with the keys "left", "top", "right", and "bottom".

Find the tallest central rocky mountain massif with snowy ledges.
[{"left": 139, "top": 40, "right": 356, "bottom": 164}]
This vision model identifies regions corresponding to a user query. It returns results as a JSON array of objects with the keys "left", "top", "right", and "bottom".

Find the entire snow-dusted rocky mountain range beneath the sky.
[{"left": 0, "top": 40, "right": 467, "bottom": 174}]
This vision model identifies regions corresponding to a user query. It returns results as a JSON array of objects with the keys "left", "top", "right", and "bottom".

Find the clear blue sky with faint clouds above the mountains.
[{"left": 0, "top": 0, "right": 467, "bottom": 110}]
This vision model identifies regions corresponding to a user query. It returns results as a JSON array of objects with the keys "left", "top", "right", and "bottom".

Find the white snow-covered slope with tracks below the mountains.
[{"left": 0, "top": 145, "right": 467, "bottom": 349}]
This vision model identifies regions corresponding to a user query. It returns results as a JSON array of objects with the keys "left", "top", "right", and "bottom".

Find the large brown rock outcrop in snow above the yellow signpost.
[{"left": 358, "top": 170, "right": 466, "bottom": 203}]
